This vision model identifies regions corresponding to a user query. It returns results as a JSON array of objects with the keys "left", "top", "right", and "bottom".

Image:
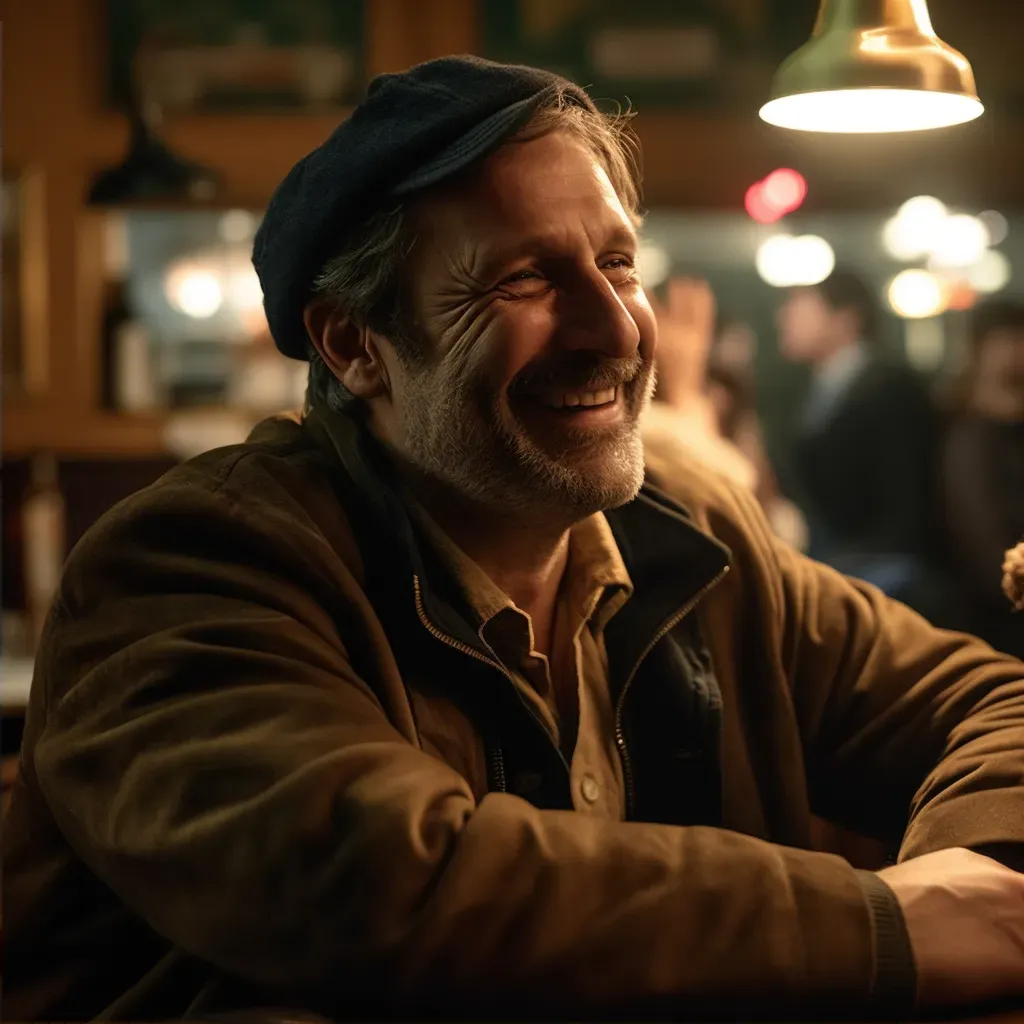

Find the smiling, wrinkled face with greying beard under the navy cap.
[{"left": 376, "top": 133, "right": 655, "bottom": 519}]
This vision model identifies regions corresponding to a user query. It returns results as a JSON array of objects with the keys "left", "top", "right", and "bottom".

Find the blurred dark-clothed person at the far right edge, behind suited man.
[{"left": 940, "top": 300, "right": 1024, "bottom": 657}]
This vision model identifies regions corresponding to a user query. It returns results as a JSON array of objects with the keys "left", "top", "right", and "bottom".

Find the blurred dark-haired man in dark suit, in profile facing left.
[{"left": 778, "top": 268, "right": 936, "bottom": 612}]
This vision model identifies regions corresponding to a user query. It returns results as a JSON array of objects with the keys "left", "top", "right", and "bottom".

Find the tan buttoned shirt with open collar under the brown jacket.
[{"left": 407, "top": 507, "right": 633, "bottom": 820}]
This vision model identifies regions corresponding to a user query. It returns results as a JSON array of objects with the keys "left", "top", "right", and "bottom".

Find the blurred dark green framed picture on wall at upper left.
[{"left": 108, "top": 0, "right": 366, "bottom": 113}]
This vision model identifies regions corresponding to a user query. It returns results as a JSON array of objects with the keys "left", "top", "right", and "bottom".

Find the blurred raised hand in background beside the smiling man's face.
[{"left": 654, "top": 278, "right": 715, "bottom": 412}]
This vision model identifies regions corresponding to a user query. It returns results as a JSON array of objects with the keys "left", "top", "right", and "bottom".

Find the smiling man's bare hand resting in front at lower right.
[{"left": 878, "top": 849, "right": 1024, "bottom": 1007}]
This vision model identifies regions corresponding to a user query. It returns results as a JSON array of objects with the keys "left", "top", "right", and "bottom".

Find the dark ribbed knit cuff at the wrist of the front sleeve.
[{"left": 857, "top": 871, "right": 918, "bottom": 1018}]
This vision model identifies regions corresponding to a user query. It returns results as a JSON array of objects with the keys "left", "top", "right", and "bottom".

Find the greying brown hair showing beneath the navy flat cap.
[{"left": 305, "top": 90, "right": 642, "bottom": 413}]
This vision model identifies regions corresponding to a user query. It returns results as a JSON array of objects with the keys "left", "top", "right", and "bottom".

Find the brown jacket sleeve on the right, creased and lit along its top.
[{"left": 775, "top": 524, "right": 1024, "bottom": 859}]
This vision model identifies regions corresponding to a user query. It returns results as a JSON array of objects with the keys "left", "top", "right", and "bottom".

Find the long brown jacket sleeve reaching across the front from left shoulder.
[{"left": 29, "top": 462, "right": 897, "bottom": 1017}]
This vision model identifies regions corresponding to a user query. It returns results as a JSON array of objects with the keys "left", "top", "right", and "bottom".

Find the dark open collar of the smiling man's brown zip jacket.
[{"left": 304, "top": 413, "right": 730, "bottom": 663}]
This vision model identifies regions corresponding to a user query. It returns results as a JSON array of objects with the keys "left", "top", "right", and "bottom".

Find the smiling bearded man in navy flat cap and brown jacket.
[{"left": 4, "top": 58, "right": 1024, "bottom": 1020}]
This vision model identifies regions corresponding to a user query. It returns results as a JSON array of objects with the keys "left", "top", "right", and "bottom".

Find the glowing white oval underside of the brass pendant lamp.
[{"left": 761, "top": 88, "right": 985, "bottom": 134}]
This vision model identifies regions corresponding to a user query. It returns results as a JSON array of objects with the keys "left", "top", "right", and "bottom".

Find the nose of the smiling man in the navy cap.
[{"left": 558, "top": 267, "right": 640, "bottom": 359}]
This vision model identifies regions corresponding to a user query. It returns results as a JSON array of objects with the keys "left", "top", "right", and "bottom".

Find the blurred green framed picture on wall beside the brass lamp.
[{"left": 479, "top": 0, "right": 816, "bottom": 110}]
